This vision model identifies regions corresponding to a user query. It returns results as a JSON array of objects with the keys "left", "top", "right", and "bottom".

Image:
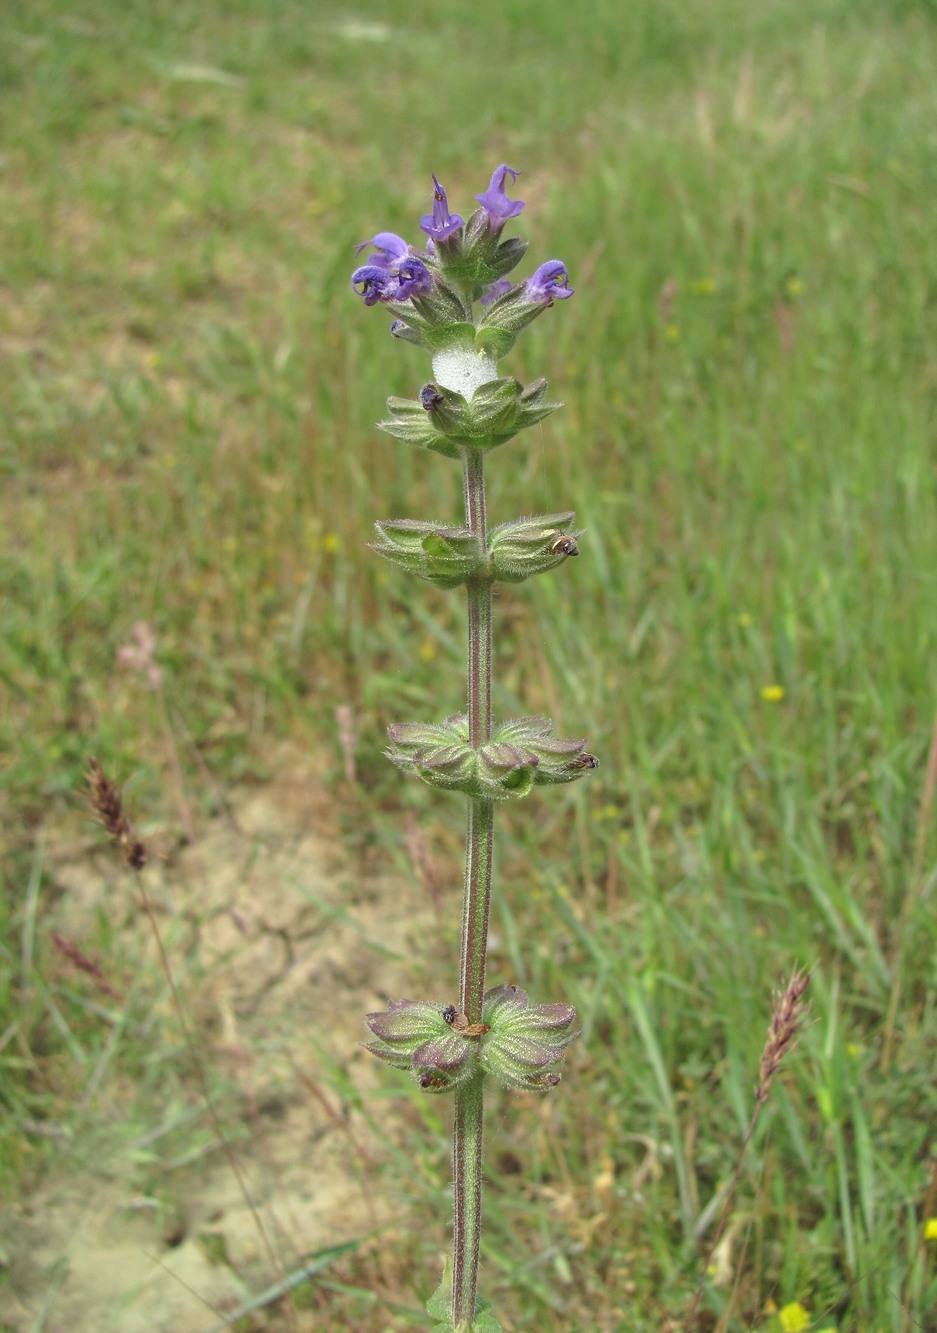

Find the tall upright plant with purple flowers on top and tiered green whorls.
[{"left": 352, "top": 165, "right": 598, "bottom": 1333}]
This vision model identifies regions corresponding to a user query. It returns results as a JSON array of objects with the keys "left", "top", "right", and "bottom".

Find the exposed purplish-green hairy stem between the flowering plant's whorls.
[{"left": 452, "top": 449, "right": 494, "bottom": 1330}]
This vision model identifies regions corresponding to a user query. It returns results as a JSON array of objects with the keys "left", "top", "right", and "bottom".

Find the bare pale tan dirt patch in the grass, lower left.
[{"left": 7, "top": 754, "right": 429, "bottom": 1333}]
